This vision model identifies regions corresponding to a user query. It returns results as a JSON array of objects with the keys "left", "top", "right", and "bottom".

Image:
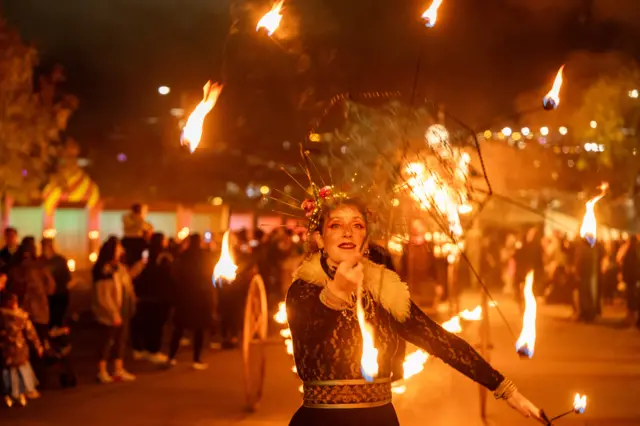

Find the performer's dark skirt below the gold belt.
[{"left": 289, "top": 404, "right": 400, "bottom": 426}]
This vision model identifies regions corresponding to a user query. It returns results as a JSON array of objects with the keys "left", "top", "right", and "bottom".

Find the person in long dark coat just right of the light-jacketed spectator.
[{"left": 131, "top": 233, "right": 175, "bottom": 363}]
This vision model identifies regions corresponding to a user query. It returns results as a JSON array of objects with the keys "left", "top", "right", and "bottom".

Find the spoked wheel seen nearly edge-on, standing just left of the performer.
[{"left": 242, "top": 274, "right": 268, "bottom": 411}]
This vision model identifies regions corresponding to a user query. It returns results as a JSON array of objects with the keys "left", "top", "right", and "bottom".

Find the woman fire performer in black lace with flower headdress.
[{"left": 287, "top": 194, "right": 543, "bottom": 426}]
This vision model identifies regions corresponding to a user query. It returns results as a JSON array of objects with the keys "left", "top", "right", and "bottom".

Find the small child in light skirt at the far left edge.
[{"left": 0, "top": 292, "right": 43, "bottom": 407}]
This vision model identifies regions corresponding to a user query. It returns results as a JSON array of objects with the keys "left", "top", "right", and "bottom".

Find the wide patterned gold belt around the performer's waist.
[{"left": 303, "top": 377, "right": 391, "bottom": 408}]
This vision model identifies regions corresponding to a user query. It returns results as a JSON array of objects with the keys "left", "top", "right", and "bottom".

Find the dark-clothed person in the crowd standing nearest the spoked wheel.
[{"left": 168, "top": 234, "right": 214, "bottom": 370}]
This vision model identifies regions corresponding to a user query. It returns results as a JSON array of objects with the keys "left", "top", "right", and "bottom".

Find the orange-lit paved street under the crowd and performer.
[{"left": 0, "top": 298, "right": 640, "bottom": 426}]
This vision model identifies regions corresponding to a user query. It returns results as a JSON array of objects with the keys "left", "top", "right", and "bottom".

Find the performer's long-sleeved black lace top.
[{"left": 287, "top": 271, "right": 504, "bottom": 391}]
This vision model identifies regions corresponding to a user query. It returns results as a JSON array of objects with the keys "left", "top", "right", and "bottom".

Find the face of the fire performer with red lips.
[{"left": 316, "top": 204, "right": 367, "bottom": 265}]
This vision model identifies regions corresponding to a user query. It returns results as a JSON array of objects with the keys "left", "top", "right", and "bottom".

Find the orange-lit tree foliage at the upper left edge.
[{"left": 0, "top": 20, "right": 77, "bottom": 204}]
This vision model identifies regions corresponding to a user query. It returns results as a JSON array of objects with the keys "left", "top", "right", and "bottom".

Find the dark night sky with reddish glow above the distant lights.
[{"left": 4, "top": 0, "right": 640, "bottom": 201}]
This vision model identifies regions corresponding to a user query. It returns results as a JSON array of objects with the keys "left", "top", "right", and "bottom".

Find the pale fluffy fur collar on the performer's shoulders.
[{"left": 293, "top": 254, "right": 411, "bottom": 322}]
